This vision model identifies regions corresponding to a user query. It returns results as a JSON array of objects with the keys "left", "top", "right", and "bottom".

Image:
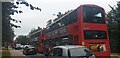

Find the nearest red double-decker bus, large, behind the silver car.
[{"left": 31, "top": 4, "right": 110, "bottom": 56}]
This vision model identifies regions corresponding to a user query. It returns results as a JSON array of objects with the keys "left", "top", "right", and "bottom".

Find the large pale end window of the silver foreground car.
[{"left": 69, "top": 47, "right": 92, "bottom": 57}]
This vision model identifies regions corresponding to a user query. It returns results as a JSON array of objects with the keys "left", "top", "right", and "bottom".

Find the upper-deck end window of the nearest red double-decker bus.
[{"left": 83, "top": 6, "right": 105, "bottom": 24}]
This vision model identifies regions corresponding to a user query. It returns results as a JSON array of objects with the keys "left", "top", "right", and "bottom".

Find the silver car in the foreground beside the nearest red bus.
[{"left": 45, "top": 45, "right": 95, "bottom": 58}]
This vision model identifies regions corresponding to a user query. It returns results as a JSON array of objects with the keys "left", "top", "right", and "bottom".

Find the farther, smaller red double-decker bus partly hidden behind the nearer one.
[{"left": 28, "top": 29, "right": 44, "bottom": 52}]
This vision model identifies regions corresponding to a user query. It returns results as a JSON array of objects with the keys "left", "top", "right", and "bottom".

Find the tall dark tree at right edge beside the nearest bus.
[{"left": 107, "top": 1, "right": 120, "bottom": 52}]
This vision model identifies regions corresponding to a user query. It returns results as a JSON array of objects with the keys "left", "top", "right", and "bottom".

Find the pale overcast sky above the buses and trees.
[{"left": 12, "top": 0, "right": 119, "bottom": 38}]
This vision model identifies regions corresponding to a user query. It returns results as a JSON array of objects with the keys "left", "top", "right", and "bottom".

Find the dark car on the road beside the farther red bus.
[{"left": 23, "top": 45, "right": 37, "bottom": 55}]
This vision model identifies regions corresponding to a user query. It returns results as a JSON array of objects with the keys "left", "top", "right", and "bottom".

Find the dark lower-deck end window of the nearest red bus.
[{"left": 84, "top": 30, "right": 107, "bottom": 39}]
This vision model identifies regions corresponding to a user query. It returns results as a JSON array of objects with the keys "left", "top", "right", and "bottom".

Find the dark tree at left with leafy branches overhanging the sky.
[{"left": 2, "top": 0, "right": 41, "bottom": 43}]
